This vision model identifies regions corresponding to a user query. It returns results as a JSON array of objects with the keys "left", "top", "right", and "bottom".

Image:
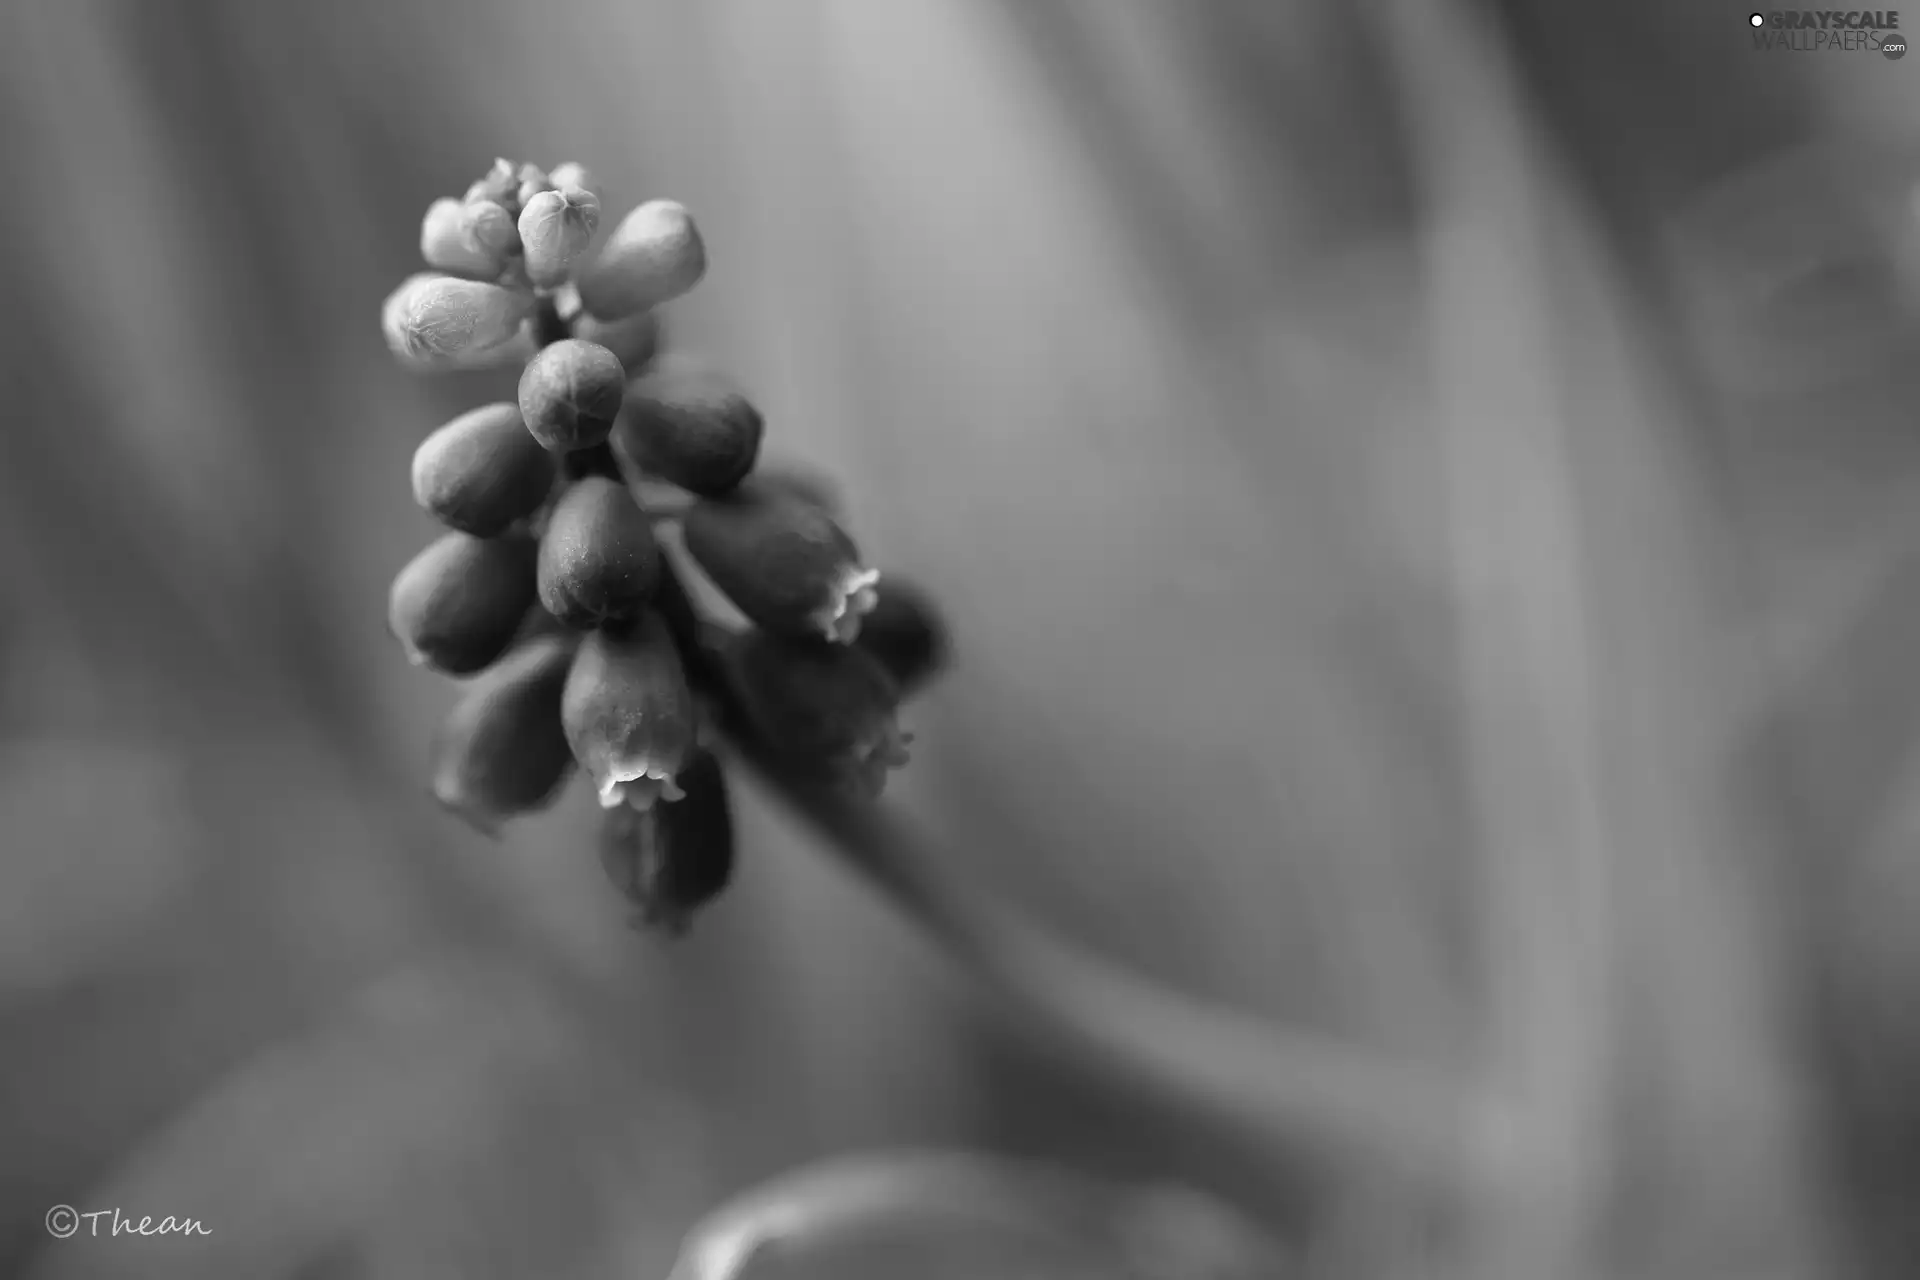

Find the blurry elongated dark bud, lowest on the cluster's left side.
[{"left": 432, "top": 635, "right": 574, "bottom": 835}]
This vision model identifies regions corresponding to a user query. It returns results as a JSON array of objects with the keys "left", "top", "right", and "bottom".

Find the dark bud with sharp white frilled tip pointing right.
[{"left": 682, "top": 493, "right": 879, "bottom": 643}]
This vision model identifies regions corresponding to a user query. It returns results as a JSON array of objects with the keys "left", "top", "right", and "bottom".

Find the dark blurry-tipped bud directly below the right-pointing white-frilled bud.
[{"left": 726, "top": 631, "right": 912, "bottom": 796}]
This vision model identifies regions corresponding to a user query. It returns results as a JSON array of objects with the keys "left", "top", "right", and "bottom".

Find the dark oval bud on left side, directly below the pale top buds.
[{"left": 413, "top": 401, "right": 553, "bottom": 537}]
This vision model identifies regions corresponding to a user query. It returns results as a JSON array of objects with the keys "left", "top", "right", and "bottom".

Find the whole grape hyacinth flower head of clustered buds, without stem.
[{"left": 382, "top": 159, "right": 945, "bottom": 931}]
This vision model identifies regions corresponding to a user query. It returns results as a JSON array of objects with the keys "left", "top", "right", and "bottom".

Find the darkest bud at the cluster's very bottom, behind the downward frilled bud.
[{"left": 599, "top": 750, "right": 733, "bottom": 933}]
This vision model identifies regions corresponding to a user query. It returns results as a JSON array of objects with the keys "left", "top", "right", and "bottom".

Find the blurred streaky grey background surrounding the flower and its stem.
[{"left": 0, "top": 0, "right": 1920, "bottom": 1280}]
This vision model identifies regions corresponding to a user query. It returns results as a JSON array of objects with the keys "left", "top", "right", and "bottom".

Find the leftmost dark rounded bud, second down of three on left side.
[{"left": 386, "top": 533, "right": 538, "bottom": 676}]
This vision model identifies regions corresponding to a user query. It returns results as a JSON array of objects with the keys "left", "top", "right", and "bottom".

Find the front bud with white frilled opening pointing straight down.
[{"left": 561, "top": 610, "right": 695, "bottom": 808}]
